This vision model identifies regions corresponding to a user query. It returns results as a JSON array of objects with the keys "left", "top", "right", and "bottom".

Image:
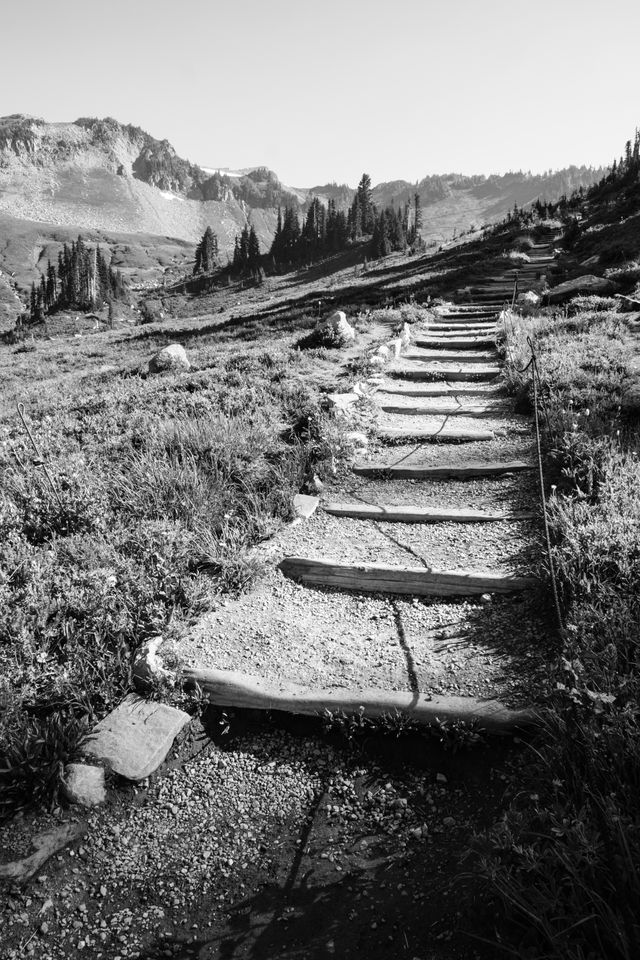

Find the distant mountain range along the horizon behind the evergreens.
[{"left": 0, "top": 114, "right": 604, "bottom": 318}]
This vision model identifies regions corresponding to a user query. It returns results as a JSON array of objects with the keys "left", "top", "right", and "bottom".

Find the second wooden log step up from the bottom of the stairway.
[{"left": 280, "top": 557, "right": 537, "bottom": 597}]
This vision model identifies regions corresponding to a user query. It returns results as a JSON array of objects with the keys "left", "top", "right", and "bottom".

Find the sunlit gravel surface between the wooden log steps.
[{"left": 172, "top": 308, "right": 549, "bottom": 704}]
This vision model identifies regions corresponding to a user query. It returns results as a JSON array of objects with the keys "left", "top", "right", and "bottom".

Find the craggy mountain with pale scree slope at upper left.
[{"left": 0, "top": 115, "right": 285, "bottom": 252}]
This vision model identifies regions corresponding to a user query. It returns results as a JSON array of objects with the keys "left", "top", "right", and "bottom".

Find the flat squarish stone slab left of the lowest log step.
[{"left": 81, "top": 694, "right": 191, "bottom": 780}]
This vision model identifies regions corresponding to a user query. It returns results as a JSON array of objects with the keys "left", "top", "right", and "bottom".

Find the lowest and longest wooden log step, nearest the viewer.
[{"left": 182, "top": 668, "right": 539, "bottom": 735}]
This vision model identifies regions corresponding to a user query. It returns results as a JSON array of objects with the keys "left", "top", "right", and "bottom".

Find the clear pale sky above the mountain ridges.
[{"left": 0, "top": 0, "right": 640, "bottom": 187}]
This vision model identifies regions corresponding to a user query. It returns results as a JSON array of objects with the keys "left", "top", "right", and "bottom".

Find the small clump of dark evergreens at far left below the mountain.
[{"left": 29, "top": 236, "right": 127, "bottom": 321}]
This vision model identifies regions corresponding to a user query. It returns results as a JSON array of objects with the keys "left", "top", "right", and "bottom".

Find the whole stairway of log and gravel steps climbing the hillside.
[{"left": 174, "top": 236, "right": 552, "bottom": 732}]
